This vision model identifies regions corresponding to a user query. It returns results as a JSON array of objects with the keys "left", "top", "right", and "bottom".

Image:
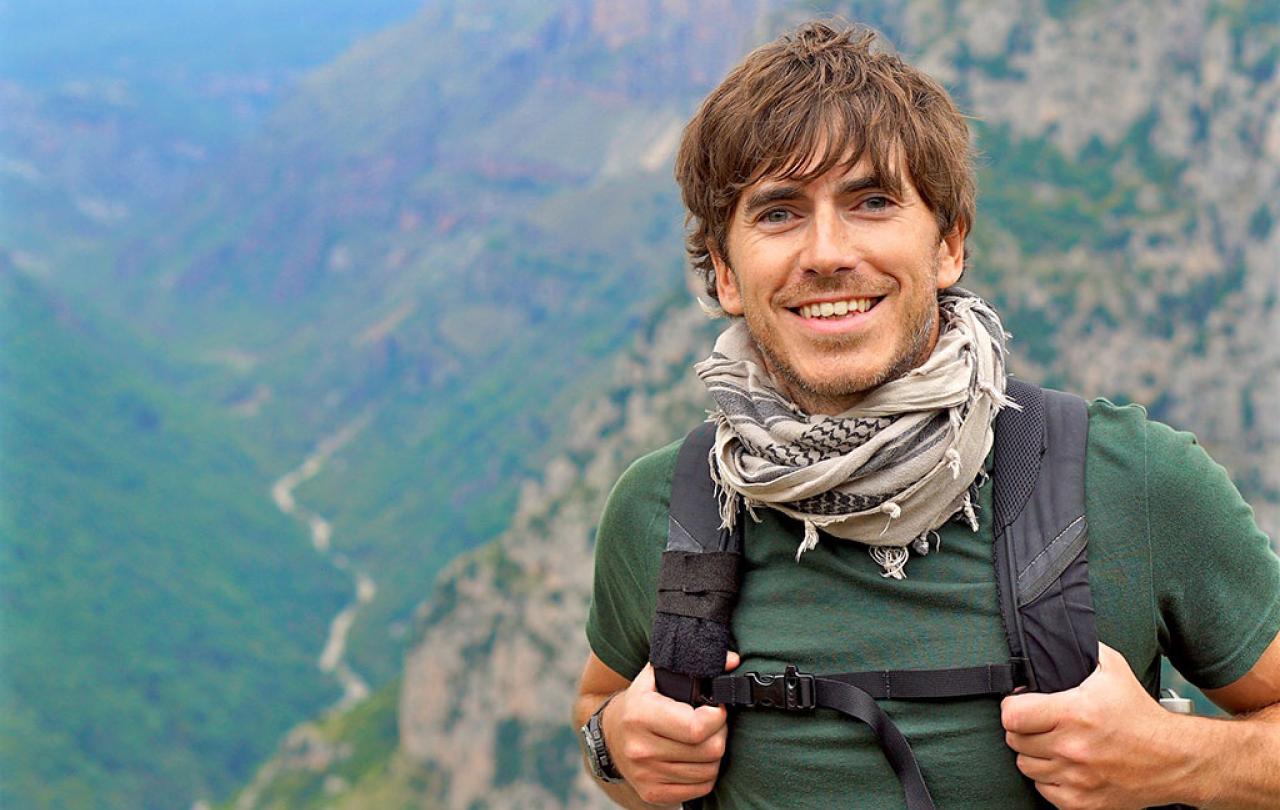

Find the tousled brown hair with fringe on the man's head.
[{"left": 676, "top": 22, "right": 975, "bottom": 301}]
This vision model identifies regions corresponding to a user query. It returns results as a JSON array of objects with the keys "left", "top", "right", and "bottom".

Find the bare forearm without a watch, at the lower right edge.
[{"left": 1172, "top": 704, "right": 1280, "bottom": 810}]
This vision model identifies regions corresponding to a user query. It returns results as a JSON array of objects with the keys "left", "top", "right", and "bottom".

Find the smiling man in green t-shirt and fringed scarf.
[{"left": 575, "top": 24, "right": 1280, "bottom": 807}]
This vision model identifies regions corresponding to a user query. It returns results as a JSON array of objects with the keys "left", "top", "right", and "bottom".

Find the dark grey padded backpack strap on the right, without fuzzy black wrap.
[{"left": 992, "top": 379, "right": 1098, "bottom": 692}]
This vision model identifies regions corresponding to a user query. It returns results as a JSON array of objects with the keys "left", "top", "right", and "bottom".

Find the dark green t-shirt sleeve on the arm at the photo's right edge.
[{"left": 1144, "top": 421, "right": 1280, "bottom": 688}]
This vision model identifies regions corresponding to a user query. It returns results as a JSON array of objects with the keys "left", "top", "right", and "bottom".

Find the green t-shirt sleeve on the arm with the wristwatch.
[{"left": 586, "top": 443, "right": 678, "bottom": 678}]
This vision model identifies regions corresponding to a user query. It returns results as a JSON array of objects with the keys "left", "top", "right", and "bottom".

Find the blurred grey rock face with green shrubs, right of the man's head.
[{"left": 929, "top": 0, "right": 1280, "bottom": 529}]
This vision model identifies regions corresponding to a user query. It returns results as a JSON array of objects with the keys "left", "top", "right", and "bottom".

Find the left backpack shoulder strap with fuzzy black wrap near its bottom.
[{"left": 649, "top": 422, "right": 742, "bottom": 704}]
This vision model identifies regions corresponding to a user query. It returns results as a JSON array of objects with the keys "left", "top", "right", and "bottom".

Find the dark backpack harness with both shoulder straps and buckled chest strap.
[{"left": 649, "top": 379, "right": 1187, "bottom": 810}]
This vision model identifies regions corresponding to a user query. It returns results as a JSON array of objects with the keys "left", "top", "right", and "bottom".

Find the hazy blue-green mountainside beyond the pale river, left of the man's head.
[{"left": 65, "top": 3, "right": 733, "bottom": 685}]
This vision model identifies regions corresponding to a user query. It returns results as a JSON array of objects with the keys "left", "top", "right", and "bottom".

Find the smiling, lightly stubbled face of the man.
[{"left": 713, "top": 159, "right": 964, "bottom": 413}]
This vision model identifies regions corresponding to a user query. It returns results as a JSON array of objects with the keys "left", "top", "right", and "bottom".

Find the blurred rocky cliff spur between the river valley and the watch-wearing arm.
[{"left": 399, "top": 305, "right": 710, "bottom": 807}]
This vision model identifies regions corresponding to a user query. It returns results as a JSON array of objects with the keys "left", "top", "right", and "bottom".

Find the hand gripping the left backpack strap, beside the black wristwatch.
[{"left": 602, "top": 651, "right": 739, "bottom": 805}]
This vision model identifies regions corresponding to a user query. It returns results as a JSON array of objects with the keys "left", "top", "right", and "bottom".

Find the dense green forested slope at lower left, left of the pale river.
[{"left": 0, "top": 264, "right": 348, "bottom": 807}]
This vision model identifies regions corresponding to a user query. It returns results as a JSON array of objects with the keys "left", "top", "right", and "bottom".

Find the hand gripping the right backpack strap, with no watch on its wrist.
[{"left": 1000, "top": 644, "right": 1178, "bottom": 810}]
